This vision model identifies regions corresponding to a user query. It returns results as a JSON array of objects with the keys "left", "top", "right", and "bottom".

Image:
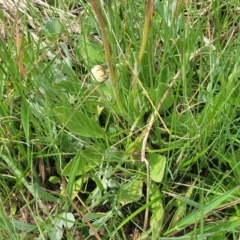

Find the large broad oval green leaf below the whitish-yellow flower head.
[{"left": 53, "top": 106, "right": 104, "bottom": 138}]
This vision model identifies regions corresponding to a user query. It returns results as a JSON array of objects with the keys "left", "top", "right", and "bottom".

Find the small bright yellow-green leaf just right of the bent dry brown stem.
[{"left": 148, "top": 153, "right": 166, "bottom": 182}]
